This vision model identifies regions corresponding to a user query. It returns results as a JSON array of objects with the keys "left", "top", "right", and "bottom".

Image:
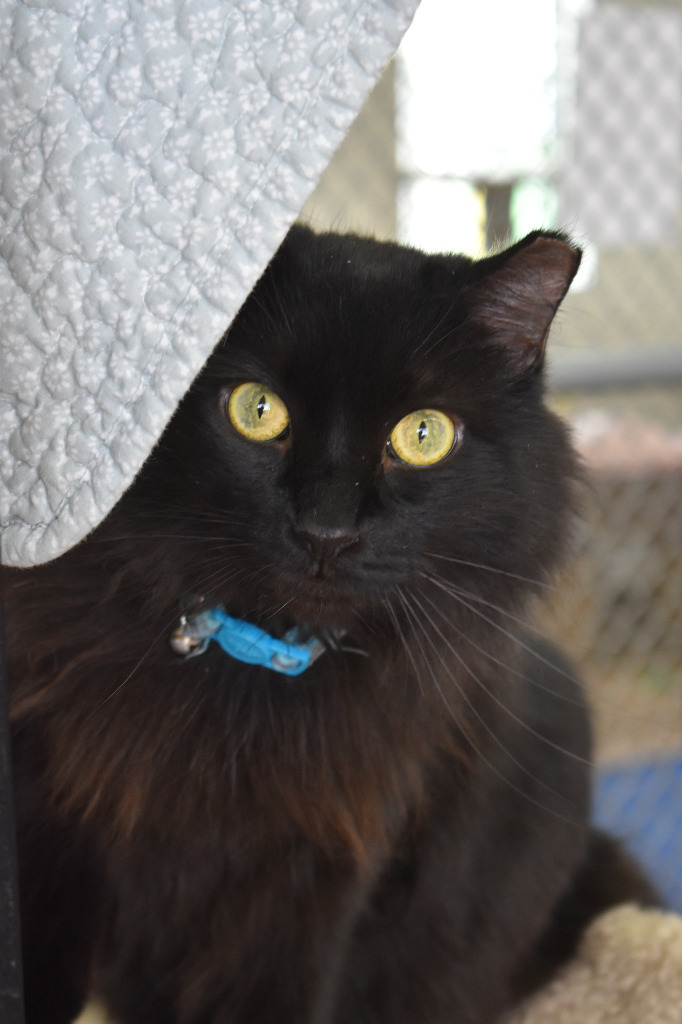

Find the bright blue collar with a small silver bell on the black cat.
[{"left": 170, "top": 606, "right": 325, "bottom": 676}]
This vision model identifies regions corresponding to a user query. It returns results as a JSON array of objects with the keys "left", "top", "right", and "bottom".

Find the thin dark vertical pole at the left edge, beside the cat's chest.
[{"left": 0, "top": 581, "right": 24, "bottom": 1024}]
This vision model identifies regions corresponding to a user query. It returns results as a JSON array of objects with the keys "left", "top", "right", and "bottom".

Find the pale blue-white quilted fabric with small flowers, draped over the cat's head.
[{"left": 0, "top": 0, "right": 418, "bottom": 565}]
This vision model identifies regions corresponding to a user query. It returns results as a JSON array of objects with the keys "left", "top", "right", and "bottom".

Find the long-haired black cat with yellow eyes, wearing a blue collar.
[{"left": 3, "top": 227, "right": 650, "bottom": 1024}]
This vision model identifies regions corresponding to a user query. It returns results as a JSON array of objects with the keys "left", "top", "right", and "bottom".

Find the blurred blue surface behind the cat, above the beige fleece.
[{"left": 594, "top": 752, "right": 682, "bottom": 913}]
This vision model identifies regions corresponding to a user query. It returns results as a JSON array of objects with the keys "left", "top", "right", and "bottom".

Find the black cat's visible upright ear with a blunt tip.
[{"left": 471, "top": 231, "right": 582, "bottom": 378}]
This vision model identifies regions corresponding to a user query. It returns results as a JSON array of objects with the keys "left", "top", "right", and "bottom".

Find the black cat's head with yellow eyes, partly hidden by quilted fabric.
[{"left": 122, "top": 227, "right": 580, "bottom": 628}]
